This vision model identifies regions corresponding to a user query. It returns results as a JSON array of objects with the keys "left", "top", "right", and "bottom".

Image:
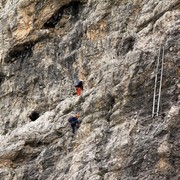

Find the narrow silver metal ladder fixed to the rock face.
[{"left": 152, "top": 46, "right": 164, "bottom": 117}]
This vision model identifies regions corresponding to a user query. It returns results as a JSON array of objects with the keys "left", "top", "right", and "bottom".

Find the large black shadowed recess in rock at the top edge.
[{"left": 43, "top": 1, "right": 81, "bottom": 29}]
